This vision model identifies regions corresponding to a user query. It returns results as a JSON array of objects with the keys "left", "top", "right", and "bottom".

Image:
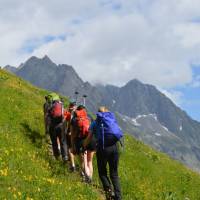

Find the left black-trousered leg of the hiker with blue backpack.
[{"left": 96, "top": 150, "right": 111, "bottom": 192}]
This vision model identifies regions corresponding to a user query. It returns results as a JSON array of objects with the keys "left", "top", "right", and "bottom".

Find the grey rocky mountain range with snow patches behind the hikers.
[{"left": 4, "top": 56, "right": 200, "bottom": 171}]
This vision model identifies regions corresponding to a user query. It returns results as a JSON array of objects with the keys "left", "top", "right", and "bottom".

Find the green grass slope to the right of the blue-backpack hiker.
[{"left": 120, "top": 136, "right": 200, "bottom": 200}]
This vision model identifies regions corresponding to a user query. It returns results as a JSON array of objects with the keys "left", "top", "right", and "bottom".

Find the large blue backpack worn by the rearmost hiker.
[{"left": 96, "top": 112, "right": 123, "bottom": 148}]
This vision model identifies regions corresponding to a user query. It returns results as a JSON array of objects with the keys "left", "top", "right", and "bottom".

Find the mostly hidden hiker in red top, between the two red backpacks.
[{"left": 64, "top": 102, "right": 76, "bottom": 172}]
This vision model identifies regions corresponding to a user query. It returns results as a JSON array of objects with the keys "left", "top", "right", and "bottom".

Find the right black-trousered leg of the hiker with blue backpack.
[{"left": 108, "top": 145, "right": 121, "bottom": 200}]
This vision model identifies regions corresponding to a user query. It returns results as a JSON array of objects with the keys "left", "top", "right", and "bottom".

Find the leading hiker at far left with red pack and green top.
[{"left": 49, "top": 93, "right": 68, "bottom": 162}]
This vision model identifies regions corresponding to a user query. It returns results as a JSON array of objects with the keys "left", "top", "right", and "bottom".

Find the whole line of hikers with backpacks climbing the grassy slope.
[{"left": 44, "top": 93, "right": 123, "bottom": 200}]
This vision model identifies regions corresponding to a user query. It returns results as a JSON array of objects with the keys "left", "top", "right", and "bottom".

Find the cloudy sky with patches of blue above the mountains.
[{"left": 0, "top": 0, "right": 200, "bottom": 121}]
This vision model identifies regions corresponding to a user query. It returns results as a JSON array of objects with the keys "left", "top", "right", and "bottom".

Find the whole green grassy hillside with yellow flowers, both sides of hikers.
[{"left": 0, "top": 70, "right": 200, "bottom": 200}]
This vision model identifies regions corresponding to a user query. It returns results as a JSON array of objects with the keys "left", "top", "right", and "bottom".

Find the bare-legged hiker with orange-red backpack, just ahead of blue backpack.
[{"left": 71, "top": 105, "right": 93, "bottom": 182}]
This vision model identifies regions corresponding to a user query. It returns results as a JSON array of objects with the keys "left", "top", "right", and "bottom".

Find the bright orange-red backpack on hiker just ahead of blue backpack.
[{"left": 75, "top": 109, "right": 90, "bottom": 138}]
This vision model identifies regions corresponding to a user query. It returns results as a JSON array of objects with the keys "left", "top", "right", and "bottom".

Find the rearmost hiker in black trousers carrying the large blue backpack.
[{"left": 83, "top": 106, "right": 123, "bottom": 200}]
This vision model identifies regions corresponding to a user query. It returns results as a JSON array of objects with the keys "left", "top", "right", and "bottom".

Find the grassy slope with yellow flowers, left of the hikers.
[{"left": 0, "top": 70, "right": 102, "bottom": 200}]
